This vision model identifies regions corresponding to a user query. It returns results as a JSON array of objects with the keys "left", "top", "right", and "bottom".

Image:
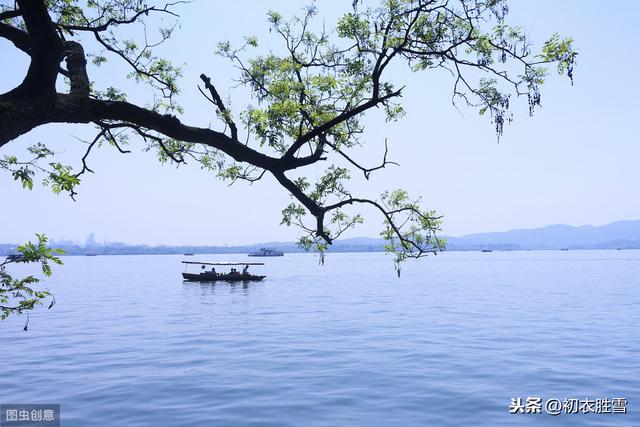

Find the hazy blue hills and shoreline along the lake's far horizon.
[{"left": 0, "top": 221, "right": 640, "bottom": 256}]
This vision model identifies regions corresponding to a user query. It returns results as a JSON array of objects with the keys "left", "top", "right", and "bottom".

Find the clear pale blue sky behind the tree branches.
[{"left": 0, "top": 0, "right": 640, "bottom": 245}]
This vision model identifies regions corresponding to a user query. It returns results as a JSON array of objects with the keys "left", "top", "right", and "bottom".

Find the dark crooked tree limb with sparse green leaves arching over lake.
[{"left": 0, "top": 0, "right": 576, "bottom": 280}]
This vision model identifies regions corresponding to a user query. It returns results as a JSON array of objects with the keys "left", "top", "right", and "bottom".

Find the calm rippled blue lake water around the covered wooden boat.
[{"left": 0, "top": 251, "right": 640, "bottom": 426}]
